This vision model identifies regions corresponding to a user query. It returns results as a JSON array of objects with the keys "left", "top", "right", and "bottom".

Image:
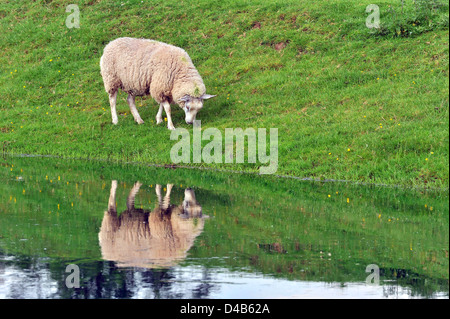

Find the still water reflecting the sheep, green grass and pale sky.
[{"left": 0, "top": 157, "right": 449, "bottom": 299}]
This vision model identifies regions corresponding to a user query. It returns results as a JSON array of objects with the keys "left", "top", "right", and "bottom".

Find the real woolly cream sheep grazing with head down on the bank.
[{"left": 100, "top": 37, "right": 215, "bottom": 130}]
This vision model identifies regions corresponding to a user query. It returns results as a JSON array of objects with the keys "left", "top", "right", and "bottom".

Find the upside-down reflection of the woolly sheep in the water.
[{"left": 99, "top": 181, "right": 206, "bottom": 268}]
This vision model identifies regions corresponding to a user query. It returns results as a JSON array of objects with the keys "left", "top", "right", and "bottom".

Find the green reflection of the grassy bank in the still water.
[{"left": 0, "top": 158, "right": 448, "bottom": 298}]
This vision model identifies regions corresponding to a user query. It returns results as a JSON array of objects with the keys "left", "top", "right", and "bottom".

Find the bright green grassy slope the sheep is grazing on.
[{"left": 0, "top": 0, "right": 449, "bottom": 188}]
